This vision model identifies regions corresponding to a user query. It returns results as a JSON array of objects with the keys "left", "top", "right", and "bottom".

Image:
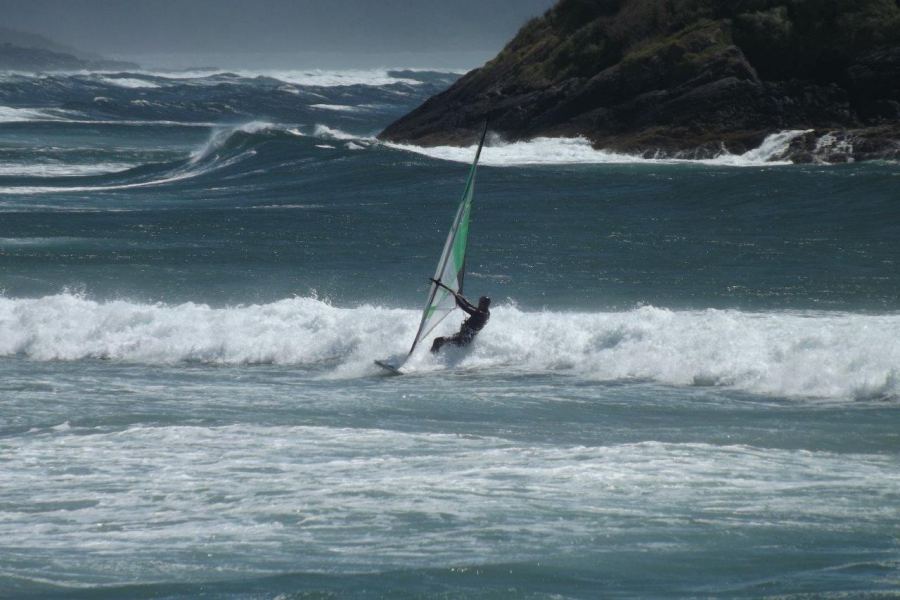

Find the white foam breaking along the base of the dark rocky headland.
[{"left": 385, "top": 130, "right": 806, "bottom": 167}]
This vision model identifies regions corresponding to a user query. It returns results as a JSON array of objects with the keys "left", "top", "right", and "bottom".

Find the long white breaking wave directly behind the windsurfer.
[{"left": 0, "top": 293, "right": 900, "bottom": 399}]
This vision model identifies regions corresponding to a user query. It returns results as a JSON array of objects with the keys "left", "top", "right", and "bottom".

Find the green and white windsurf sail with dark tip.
[{"left": 409, "top": 123, "right": 487, "bottom": 354}]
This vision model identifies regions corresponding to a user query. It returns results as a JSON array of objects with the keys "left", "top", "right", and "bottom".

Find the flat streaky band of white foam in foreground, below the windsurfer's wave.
[{"left": 0, "top": 418, "right": 900, "bottom": 582}]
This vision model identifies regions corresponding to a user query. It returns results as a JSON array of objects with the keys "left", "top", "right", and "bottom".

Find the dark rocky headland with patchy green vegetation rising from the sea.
[{"left": 381, "top": 0, "right": 900, "bottom": 159}]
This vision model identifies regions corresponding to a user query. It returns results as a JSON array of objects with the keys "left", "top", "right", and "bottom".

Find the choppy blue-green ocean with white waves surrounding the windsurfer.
[{"left": 0, "top": 70, "right": 900, "bottom": 599}]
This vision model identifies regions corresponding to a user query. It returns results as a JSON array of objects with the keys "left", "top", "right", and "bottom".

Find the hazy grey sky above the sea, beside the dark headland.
[{"left": 0, "top": 0, "right": 554, "bottom": 66}]
